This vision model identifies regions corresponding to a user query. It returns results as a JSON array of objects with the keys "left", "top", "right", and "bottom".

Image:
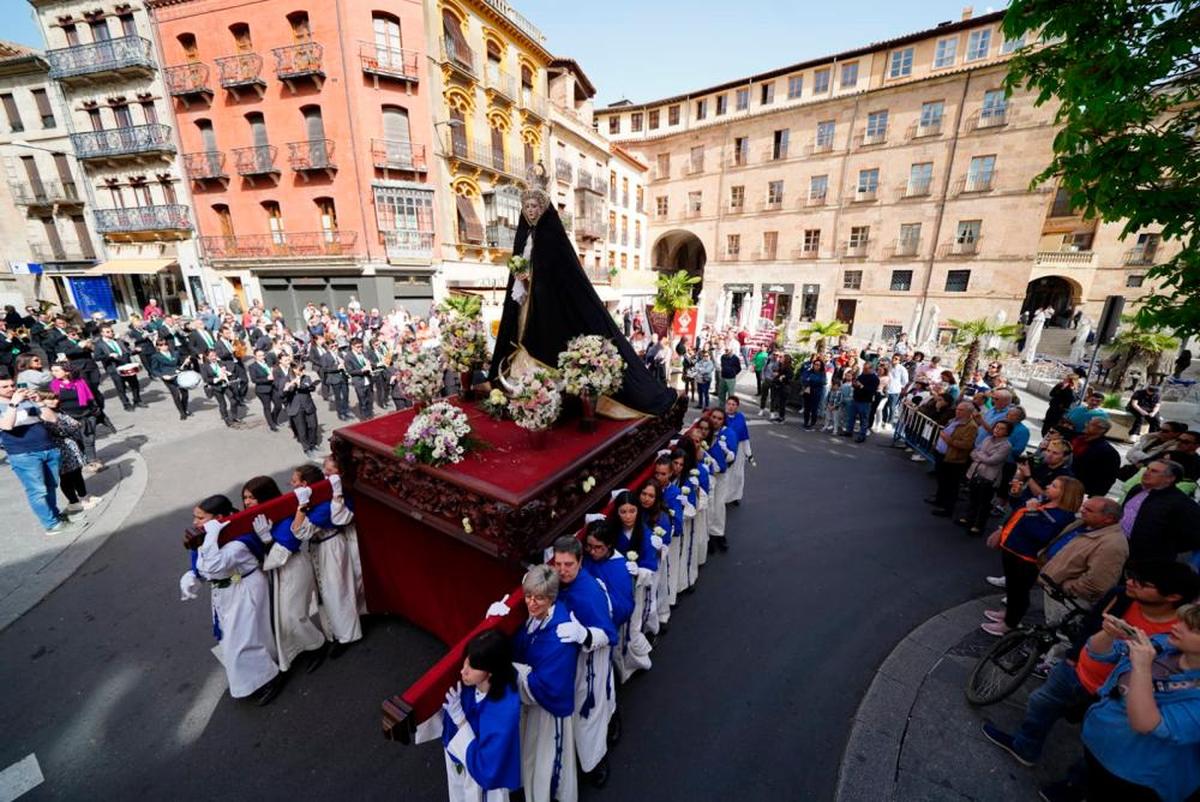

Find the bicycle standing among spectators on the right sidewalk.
[{"left": 965, "top": 574, "right": 1087, "bottom": 707}]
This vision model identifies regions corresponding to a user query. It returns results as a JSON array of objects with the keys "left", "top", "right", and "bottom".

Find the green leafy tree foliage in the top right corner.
[{"left": 1002, "top": 0, "right": 1200, "bottom": 335}]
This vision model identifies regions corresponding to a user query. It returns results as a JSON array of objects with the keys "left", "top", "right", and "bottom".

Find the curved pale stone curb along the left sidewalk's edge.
[{"left": 0, "top": 450, "right": 150, "bottom": 632}]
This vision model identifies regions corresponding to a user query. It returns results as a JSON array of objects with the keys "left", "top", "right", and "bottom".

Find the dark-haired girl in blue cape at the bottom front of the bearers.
[{"left": 442, "top": 629, "right": 521, "bottom": 802}]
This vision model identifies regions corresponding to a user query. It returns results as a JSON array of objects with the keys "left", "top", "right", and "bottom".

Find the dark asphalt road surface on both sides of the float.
[{"left": 0, "top": 410, "right": 996, "bottom": 802}]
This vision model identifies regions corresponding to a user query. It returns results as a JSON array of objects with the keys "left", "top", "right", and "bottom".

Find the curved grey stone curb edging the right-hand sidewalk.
[{"left": 834, "top": 599, "right": 988, "bottom": 802}]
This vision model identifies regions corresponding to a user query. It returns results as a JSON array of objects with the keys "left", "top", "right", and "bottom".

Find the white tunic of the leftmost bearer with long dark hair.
[{"left": 196, "top": 531, "right": 280, "bottom": 699}]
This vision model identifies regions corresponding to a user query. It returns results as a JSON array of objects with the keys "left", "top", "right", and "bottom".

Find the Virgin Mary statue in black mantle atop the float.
[{"left": 488, "top": 164, "right": 678, "bottom": 418}]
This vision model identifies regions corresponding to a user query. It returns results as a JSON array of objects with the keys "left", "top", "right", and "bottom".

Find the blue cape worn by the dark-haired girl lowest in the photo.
[{"left": 442, "top": 688, "right": 521, "bottom": 791}]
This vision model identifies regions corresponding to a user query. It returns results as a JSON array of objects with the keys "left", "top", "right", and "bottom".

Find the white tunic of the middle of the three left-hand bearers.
[{"left": 264, "top": 544, "right": 325, "bottom": 671}]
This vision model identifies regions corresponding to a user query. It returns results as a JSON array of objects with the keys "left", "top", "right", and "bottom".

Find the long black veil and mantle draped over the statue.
[{"left": 488, "top": 207, "right": 677, "bottom": 415}]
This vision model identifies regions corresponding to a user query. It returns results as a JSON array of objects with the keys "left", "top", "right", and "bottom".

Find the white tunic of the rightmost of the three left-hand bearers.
[{"left": 296, "top": 499, "right": 362, "bottom": 644}]
